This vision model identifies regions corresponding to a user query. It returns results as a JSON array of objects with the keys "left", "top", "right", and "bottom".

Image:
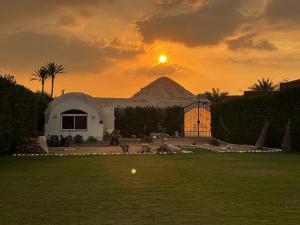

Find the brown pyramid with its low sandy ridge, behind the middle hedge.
[{"left": 97, "top": 77, "right": 195, "bottom": 108}]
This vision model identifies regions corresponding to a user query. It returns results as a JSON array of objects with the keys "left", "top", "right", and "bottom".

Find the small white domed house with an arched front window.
[{"left": 45, "top": 93, "right": 115, "bottom": 141}]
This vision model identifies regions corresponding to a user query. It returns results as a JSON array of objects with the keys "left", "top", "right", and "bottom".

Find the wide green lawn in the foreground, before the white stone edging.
[{"left": 0, "top": 152, "right": 300, "bottom": 225}]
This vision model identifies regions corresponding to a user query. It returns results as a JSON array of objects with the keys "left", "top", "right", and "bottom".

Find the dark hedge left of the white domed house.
[{"left": 0, "top": 76, "right": 49, "bottom": 155}]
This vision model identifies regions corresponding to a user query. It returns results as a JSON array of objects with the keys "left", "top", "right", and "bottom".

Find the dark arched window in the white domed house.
[{"left": 61, "top": 110, "right": 88, "bottom": 130}]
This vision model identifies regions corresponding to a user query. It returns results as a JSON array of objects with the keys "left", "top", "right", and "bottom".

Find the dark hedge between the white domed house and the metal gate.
[{"left": 115, "top": 106, "right": 184, "bottom": 137}]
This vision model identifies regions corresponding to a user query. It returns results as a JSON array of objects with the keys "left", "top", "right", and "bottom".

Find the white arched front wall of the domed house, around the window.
[{"left": 45, "top": 100, "right": 104, "bottom": 141}]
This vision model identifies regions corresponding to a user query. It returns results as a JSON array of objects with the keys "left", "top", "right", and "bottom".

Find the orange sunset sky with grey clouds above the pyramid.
[{"left": 0, "top": 0, "right": 300, "bottom": 97}]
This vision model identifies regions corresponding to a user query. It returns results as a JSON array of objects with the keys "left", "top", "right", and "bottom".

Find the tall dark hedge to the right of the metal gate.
[{"left": 212, "top": 89, "right": 300, "bottom": 151}]
